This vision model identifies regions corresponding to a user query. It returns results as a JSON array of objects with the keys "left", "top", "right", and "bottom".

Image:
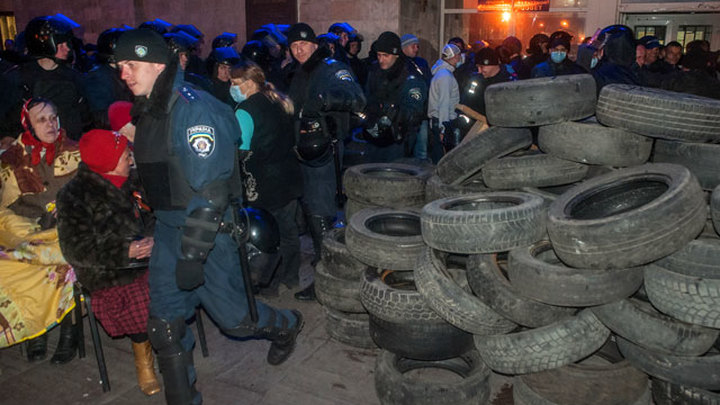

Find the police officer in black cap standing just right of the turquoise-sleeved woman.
[{"left": 287, "top": 23, "right": 365, "bottom": 300}]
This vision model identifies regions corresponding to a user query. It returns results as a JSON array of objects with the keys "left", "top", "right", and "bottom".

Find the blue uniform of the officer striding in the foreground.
[{"left": 135, "top": 68, "right": 295, "bottom": 403}]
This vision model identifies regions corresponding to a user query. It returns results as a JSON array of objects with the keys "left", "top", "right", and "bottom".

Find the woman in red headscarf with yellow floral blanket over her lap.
[{"left": 0, "top": 98, "right": 80, "bottom": 364}]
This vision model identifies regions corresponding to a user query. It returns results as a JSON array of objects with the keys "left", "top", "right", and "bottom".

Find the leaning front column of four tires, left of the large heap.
[{"left": 345, "top": 207, "right": 492, "bottom": 405}]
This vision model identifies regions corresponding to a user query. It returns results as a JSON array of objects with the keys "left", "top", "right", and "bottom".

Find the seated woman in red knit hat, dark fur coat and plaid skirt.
[{"left": 57, "top": 129, "right": 160, "bottom": 395}]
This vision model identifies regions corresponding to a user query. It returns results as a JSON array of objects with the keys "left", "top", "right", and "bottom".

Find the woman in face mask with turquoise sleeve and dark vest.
[{"left": 230, "top": 61, "right": 302, "bottom": 296}]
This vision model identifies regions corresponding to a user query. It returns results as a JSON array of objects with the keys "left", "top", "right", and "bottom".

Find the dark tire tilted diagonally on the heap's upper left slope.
[{"left": 430, "top": 127, "right": 532, "bottom": 185}]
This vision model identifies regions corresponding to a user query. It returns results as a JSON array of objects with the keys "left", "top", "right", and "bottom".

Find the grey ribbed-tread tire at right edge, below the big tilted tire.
[{"left": 645, "top": 265, "right": 720, "bottom": 328}]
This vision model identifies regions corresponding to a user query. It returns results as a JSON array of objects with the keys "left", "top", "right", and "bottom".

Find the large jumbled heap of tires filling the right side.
[{"left": 422, "top": 75, "right": 720, "bottom": 404}]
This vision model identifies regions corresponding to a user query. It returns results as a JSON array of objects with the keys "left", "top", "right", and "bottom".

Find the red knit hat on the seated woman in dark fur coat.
[{"left": 79, "top": 129, "right": 128, "bottom": 174}]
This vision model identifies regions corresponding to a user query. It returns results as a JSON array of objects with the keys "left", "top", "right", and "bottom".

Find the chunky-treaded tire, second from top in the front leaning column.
[{"left": 360, "top": 268, "right": 442, "bottom": 322}]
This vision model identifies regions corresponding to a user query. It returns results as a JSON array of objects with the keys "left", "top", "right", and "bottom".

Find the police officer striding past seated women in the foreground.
[{"left": 115, "top": 30, "right": 302, "bottom": 405}]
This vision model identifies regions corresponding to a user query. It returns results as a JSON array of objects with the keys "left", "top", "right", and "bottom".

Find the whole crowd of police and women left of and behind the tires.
[{"left": 0, "top": 12, "right": 720, "bottom": 404}]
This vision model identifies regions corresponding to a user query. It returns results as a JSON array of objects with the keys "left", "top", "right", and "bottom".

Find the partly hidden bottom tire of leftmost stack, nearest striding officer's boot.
[{"left": 325, "top": 307, "right": 377, "bottom": 349}]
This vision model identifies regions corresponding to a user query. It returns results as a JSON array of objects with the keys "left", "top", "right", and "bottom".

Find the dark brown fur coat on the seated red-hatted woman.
[{"left": 57, "top": 163, "right": 154, "bottom": 291}]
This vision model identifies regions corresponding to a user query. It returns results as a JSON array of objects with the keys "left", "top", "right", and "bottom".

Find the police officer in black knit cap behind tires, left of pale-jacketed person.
[{"left": 364, "top": 31, "right": 428, "bottom": 162}]
